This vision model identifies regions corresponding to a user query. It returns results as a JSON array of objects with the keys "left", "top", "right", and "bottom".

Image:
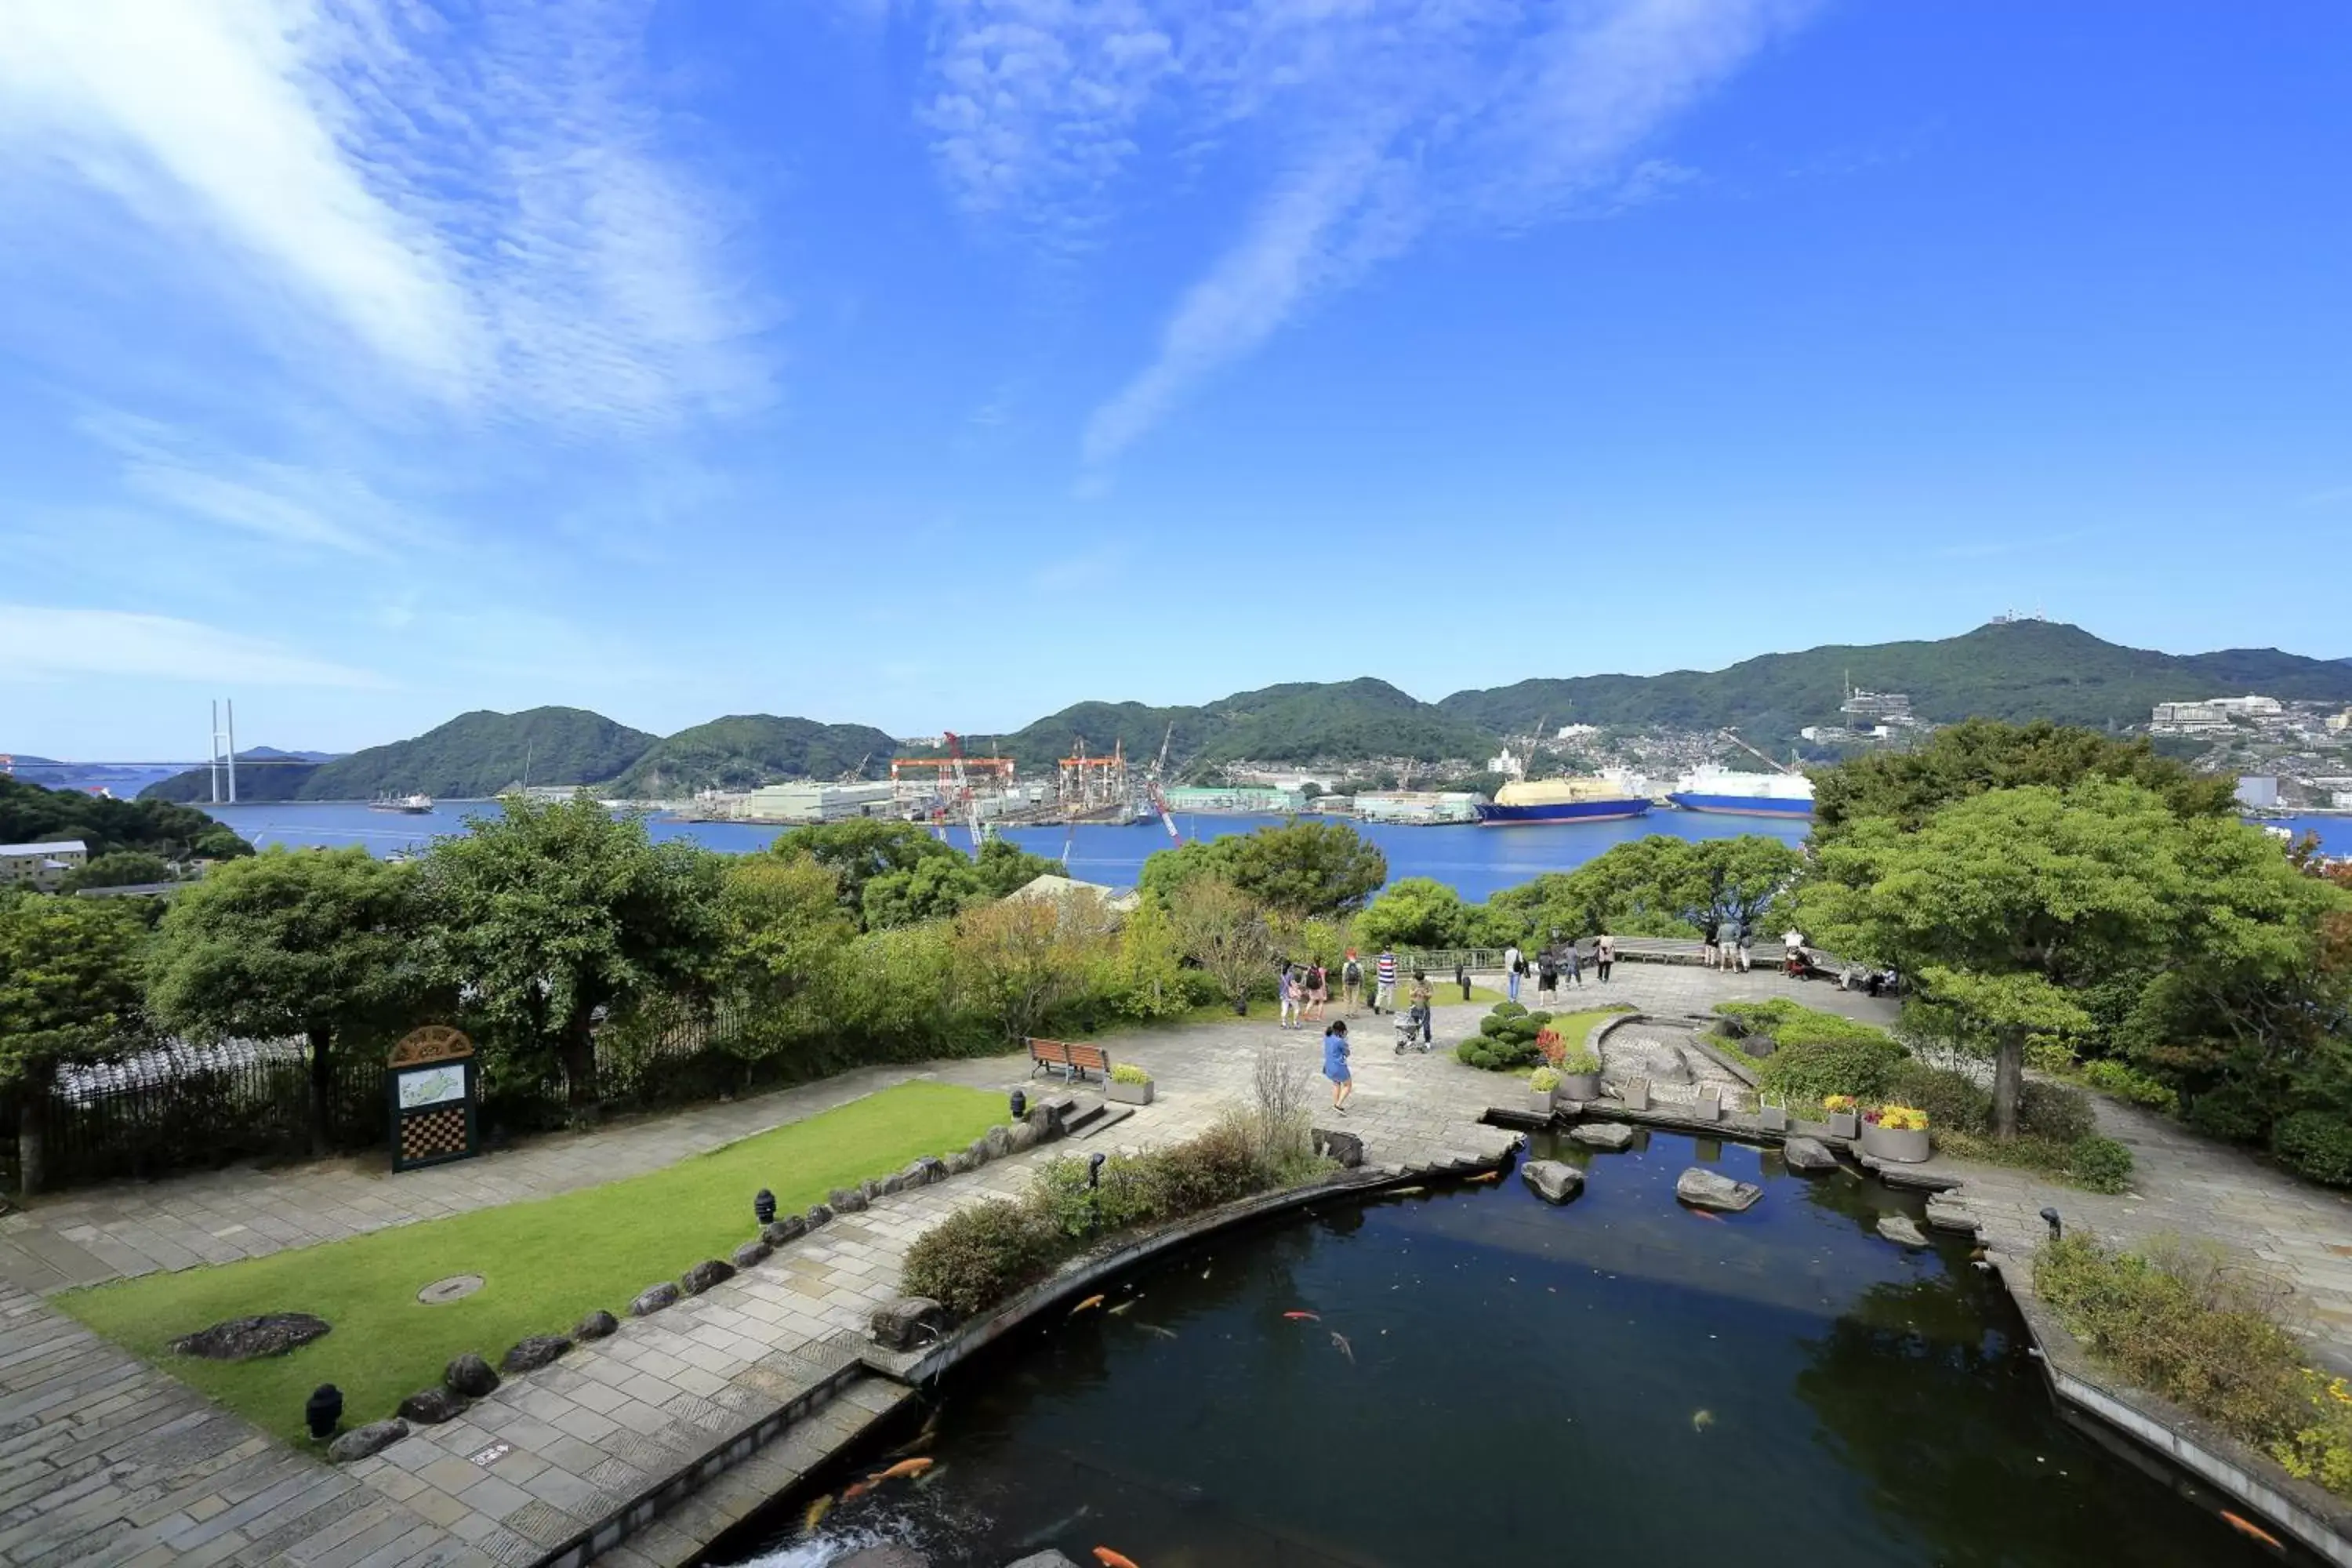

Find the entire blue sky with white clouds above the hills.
[{"left": 0, "top": 0, "right": 2352, "bottom": 757}]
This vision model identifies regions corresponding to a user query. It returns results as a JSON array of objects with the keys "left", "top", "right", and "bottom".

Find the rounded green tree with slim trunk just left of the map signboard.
[{"left": 148, "top": 846, "right": 416, "bottom": 1154}]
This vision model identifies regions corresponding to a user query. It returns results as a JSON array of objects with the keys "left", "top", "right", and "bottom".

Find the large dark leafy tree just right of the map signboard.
[{"left": 423, "top": 794, "right": 722, "bottom": 1105}]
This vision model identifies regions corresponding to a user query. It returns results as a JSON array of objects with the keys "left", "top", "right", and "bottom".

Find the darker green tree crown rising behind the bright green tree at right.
[{"left": 1813, "top": 720, "right": 2237, "bottom": 844}]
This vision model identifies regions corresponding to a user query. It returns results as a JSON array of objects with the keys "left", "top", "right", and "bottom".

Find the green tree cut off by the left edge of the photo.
[{"left": 0, "top": 898, "right": 146, "bottom": 1192}]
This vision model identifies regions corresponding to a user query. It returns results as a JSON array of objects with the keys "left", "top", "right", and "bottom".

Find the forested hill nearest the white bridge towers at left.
[{"left": 141, "top": 708, "right": 656, "bottom": 799}]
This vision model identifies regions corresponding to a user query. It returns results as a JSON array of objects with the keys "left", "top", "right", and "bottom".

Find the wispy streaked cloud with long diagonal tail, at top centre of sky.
[{"left": 924, "top": 0, "right": 1806, "bottom": 475}]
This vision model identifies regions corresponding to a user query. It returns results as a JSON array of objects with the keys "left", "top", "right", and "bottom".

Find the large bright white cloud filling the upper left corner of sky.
[{"left": 0, "top": 0, "right": 764, "bottom": 428}]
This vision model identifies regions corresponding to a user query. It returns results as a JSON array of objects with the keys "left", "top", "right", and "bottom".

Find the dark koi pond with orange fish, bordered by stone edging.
[{"left": 710, "top": 1133, "right": 2277, "bottom": 1568}]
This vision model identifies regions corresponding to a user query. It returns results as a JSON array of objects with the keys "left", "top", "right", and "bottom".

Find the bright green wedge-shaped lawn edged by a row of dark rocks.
[{"left": 56, "top": 1081, "right": 1004, "bottom": 1443}]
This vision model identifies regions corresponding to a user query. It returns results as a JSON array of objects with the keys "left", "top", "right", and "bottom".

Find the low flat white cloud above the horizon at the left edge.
[{"left": 0, "top": 604, "right": 388, "bottom": 689}]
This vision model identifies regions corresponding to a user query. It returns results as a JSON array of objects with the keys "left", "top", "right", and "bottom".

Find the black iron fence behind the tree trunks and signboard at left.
[{"left": 0, "top": 1006, "right": 755, "bottom": 1192}]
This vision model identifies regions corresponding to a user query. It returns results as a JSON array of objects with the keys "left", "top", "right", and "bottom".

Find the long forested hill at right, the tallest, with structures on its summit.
[{"left": 1437, "top": 621, "right": 2352, "bottom": 743}]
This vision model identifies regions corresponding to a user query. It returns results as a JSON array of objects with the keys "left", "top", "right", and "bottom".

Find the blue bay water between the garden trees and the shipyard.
[{"left": 207, "top": 799, "right": 2352, "bottom": 900}]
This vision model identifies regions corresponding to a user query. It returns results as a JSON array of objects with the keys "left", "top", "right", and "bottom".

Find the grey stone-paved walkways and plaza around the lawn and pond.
[{"left": 0, "top": 964, "right": 2352, "bottom": 1568}]
